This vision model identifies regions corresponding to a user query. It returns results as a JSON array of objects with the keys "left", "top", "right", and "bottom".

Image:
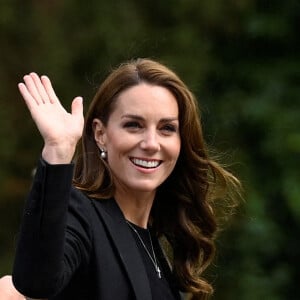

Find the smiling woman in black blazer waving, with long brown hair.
[{"left": 13, "top": 59, "right": 239, "bottom": 300}]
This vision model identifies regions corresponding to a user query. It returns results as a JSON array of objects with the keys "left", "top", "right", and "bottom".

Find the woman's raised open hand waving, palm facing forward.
[{"left": 18, "top": 73, "right": 84, "bottom": 164}]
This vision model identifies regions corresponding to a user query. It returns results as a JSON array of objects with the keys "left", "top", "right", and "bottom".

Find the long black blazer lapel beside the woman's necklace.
[{"left": 92, "top": 199, "right": 152, "bottom": 300}]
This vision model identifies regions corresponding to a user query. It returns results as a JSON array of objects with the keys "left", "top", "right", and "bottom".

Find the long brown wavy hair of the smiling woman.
[{"left": 74, "top": 59, "right": 239, "bottom": 299}]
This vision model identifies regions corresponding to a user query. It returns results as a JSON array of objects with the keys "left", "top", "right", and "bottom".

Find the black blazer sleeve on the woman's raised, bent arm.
[{"left": 13, "top": 160, "right": 90, "bottom": 298}]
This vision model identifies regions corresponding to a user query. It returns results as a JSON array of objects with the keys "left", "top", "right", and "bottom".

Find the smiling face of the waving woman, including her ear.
[{"left": 94, "top": 83, "right": 180, "bottom": 193}]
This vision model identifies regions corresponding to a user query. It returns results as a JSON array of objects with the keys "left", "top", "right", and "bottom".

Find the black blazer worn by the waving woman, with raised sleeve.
[{"left": 13, "top": 161, "right": 179, "bottom": 300}]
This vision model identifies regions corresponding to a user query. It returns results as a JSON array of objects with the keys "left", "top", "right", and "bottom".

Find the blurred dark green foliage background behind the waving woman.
[{"left": 0, "top": 0, "right": 300, "bottom": 300}]
